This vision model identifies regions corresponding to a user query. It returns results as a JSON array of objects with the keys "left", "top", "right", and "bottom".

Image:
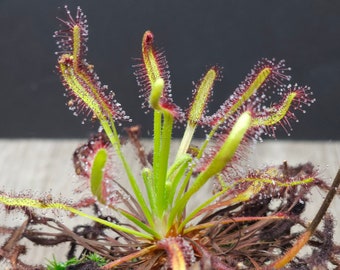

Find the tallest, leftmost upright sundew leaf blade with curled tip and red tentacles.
[{"left": 54, "top": 7, "right": 129, "bottom": 121}]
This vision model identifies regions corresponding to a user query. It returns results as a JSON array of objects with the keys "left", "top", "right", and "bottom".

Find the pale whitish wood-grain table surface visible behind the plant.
[{"left": 0, "top": 139, "right": 340, "bottom": 269}]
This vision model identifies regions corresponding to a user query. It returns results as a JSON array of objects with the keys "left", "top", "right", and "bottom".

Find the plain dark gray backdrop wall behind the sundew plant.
[{"left": 0, "top": 0, "right": 340, "bottom": 140}]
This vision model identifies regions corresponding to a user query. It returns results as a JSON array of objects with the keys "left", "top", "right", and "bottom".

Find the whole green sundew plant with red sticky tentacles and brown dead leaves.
[{"left": 0, "top": 7, "right": 340, "bottom": 270}]
